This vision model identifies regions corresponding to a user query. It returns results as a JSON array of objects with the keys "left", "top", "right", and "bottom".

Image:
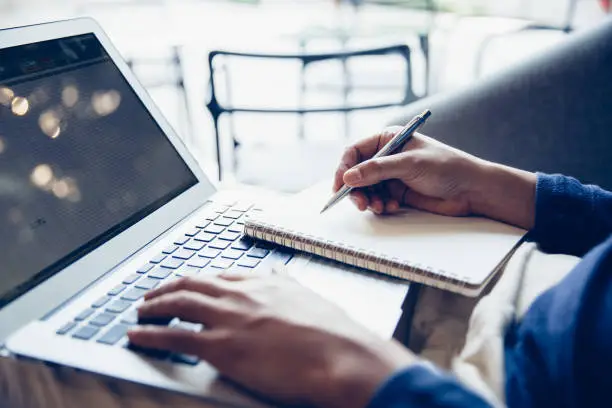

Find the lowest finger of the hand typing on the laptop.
[{"left": 128, "top": 326, "right": 216, "bottom": 359}]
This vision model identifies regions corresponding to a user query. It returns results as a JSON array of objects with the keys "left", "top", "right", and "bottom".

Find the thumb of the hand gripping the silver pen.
[{"left": 344, "top": 152, "right": 412, "bottom": 187}]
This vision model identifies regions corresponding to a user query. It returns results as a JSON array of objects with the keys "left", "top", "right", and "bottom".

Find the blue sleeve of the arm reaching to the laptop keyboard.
[{"left": 368, "top": 364, "right": 490, "bottom": 408}]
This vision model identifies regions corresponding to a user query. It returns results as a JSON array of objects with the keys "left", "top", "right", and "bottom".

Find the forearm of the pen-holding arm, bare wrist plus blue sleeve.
[{"left": 469, "top": 161, "right": 612, "bottom": 255}]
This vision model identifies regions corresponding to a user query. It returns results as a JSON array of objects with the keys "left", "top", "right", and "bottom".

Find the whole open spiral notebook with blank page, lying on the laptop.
[{"left": 245, "top": 182, "right": 526, "bottom": 296}]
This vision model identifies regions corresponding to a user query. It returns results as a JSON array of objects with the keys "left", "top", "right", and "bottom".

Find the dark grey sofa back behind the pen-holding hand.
[{"left": 394, "top": 19, "right": 612, "bottom": 190}]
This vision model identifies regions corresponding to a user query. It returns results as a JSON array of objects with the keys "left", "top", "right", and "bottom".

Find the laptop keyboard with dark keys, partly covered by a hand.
[{"left": 56, "top": 203, "right": 293, "bottom": 365}]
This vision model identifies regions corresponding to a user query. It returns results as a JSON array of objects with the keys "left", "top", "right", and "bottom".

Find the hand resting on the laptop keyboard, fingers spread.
[{"left": 129, "top": 275, "right": 416, "bottom": 407}]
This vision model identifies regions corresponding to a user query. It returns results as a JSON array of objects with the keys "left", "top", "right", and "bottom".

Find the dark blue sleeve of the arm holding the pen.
[{"left": 529, "top": 173, "right": 612, "bottom": 256}]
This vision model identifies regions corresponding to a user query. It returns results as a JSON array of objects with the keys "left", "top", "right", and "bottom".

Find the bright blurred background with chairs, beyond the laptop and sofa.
[{"left": 0, "top": 0, "right": 610, "bottom": 192}]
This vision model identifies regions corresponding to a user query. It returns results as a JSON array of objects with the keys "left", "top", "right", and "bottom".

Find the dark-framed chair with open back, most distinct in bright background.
[{"left": 206, "top": 45, "right": 417, "bottom": 179}]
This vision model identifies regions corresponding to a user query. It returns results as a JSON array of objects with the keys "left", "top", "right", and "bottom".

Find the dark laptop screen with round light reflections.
[{"left": 0, "top": 34, "right": 197, "bottom": 307}]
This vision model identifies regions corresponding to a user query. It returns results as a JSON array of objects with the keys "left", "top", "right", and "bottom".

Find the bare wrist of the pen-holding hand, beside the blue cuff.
[{"left": 469, "top": 160, "right": 537, "bottom": 229}]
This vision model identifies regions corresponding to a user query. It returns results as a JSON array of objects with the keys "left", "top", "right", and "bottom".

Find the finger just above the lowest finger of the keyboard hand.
[{"left": 138, "top": 290, "right": 228, "bottom": 327}]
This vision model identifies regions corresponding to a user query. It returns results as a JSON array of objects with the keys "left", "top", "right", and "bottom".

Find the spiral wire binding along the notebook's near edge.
[{"left": 244, "top": 218, "right": 471, "bottom": 293}]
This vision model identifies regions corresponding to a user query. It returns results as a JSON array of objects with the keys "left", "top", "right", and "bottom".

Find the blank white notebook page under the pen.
[{"left": 249, "top": 185, "right": 525, "bottom": 285}]
